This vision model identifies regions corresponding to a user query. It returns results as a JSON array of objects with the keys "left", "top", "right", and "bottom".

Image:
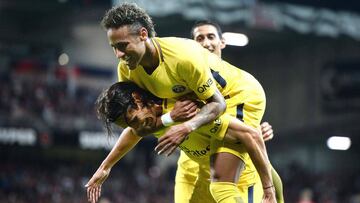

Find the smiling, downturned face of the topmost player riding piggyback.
[{"left": 107, "top": 25, "right": 147, "bottom": 70}]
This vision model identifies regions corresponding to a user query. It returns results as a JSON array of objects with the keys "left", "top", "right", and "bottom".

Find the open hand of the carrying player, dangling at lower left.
[{"left": 85, "top": 169, "right": 110, "bottom": 203}]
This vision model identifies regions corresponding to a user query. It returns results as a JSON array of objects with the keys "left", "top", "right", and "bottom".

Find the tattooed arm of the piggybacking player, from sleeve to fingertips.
[{"left": 155, "top": 88, "right": 226, "bottom": 156}]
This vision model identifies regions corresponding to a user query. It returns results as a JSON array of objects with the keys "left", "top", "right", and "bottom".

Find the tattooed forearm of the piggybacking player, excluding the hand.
[{"left": 185, "top": 90, "right": 226, "bottom": 131}]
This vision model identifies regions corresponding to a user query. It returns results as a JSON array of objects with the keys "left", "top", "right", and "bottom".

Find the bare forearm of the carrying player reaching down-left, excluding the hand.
[{"left": 99, "top": 127, "right": 141, "bottom": 170}]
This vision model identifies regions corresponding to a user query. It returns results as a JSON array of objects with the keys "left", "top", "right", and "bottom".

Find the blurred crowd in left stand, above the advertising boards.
[{"left": 0, "top": 58, "right": 100, "bottom": 132}]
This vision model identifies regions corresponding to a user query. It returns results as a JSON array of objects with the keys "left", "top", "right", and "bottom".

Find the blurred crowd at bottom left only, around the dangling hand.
[{"left": 0, "top": 161, "right": 173, "bottom": 203}]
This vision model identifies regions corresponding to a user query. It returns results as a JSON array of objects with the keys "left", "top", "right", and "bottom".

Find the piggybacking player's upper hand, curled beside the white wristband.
[{"left": 170, "top": 100, "right": 197, "bottom": 122}]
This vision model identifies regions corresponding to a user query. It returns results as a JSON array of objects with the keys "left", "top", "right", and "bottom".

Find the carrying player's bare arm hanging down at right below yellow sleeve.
[{"left": 224, "top": 119, "right": 276, "bottom": 202}]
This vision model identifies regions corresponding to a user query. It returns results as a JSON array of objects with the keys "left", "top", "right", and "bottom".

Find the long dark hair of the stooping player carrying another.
[{"left": 95, "top": 82, "right": 162, "bottom": 136}]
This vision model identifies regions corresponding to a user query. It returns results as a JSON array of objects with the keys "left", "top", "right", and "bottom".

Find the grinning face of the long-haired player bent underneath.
[{"left": 125, "top": 103, "right": 161, "bottom": 135}]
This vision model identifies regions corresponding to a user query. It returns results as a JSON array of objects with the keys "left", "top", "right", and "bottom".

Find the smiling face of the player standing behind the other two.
[{"left": 193, "top": 25, "right": 225, "bottom": 57}]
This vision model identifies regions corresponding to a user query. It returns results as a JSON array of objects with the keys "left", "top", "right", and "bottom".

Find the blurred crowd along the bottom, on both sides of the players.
[{"left": 0, "top": 161, "right": 360, "bottom": 203}]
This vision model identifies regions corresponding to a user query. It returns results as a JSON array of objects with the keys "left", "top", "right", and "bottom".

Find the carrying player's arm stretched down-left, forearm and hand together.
[{"left": 85, "top": 127, "right": 141, "bottom": 203}]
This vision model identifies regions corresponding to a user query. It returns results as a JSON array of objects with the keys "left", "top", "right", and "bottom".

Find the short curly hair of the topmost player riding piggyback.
[{"left": 101, "top": 3, "right": 156, "bottom": 37}]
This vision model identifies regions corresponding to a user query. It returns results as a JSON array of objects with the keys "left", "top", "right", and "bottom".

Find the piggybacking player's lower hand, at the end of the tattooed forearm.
[{"left": 155, "top": 123, "right": 191, "bottom": 156}]
